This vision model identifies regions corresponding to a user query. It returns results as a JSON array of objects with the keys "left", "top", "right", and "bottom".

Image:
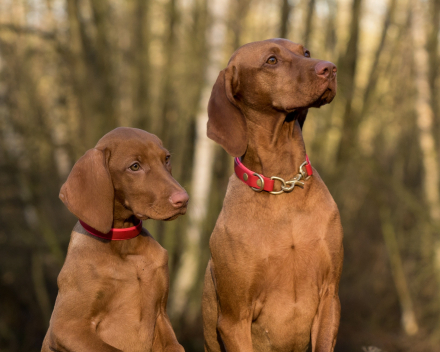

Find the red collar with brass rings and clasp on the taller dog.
[{"left": 234, "top": 155, "right": 313, "bottom": 194}]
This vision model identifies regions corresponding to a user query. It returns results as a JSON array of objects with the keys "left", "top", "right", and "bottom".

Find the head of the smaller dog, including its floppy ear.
[{"left": 60, "top": 127, "right": 188, "bottom": 233}]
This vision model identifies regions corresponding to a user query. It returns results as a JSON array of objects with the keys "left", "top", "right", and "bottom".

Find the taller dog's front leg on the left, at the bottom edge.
[{"left": 217, "top": 313, "right": 253, "bottom": 352}]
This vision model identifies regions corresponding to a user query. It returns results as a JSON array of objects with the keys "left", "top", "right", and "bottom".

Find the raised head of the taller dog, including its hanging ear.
[{"left": 208, "top": 39, "right": 337, "bottom": 156}]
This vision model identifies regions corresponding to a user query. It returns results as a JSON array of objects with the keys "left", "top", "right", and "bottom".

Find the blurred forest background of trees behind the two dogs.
[{"left": 0, "top": 0, "right": 440, "bottom": 352}]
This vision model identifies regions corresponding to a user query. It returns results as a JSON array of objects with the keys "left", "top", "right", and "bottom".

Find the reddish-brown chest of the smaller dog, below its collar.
[{"left": 54, "top": 237, "right": 168, "bottom": 352}]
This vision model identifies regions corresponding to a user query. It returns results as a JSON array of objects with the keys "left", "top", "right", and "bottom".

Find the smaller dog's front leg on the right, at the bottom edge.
[{"left": 152, "top": 313, "right": 184, "bottom": 352}]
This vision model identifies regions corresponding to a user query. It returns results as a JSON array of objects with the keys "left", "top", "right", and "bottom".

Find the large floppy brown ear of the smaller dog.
[{"left": 60, "top": 148, "right": 114, "bottom": 233}]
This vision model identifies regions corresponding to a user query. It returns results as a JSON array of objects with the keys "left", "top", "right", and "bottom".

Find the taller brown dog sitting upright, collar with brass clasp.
[{"left": 203, "top": 39, "right": 343, "bottom": 352}]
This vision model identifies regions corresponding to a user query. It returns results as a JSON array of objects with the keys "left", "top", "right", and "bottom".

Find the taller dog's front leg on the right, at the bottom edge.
[{"left": 312, "top": 291, "right": 341, "bottom": 352}]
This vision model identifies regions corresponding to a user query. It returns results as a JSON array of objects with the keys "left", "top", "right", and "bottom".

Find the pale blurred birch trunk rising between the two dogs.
[{"left": 171, "top": 0, "right": 228, "bottom": 320}]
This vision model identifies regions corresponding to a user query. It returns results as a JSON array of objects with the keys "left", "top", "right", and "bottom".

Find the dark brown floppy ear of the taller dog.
[{"left": 208, "top": 67, "right": 247, "bottom": 157}]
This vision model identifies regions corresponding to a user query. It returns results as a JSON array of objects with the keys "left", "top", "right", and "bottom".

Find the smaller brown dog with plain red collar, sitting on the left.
[{"left": 42, "top": 127, "right": 188, "bottom": 352}]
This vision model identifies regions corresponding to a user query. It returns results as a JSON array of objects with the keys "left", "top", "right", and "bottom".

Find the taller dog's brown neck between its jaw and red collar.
[{"left": 242, "top": 111, "right": 306, "bottom": 180}]
